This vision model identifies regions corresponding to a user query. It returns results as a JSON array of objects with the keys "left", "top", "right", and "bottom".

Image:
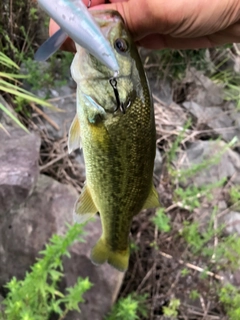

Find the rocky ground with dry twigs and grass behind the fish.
[{"left": 0, "top": 48, "right": 240, "bottom": 320}]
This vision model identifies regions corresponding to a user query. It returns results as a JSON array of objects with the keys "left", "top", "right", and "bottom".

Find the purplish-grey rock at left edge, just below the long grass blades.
[{"left": 0, "top": 126, "right": 40, "bottom": 221}]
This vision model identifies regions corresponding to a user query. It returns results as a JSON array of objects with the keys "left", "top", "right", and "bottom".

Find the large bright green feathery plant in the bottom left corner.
[{"left": 0, "top": 224, "right": 91, "bottom": 320}]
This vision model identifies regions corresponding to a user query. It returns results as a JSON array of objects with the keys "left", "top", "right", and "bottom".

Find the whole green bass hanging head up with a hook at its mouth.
[{"left": 68, "top": 10, "right": 160, "bottom": 272}]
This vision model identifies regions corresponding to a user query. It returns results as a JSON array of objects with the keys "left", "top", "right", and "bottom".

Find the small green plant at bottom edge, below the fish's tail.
[{"left": 105, "top": 294, "right": 147, "bottom": 320}]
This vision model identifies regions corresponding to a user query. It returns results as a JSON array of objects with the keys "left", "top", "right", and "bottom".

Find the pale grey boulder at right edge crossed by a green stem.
[{"left": 176, "top": 141, "right": 240, "bottom": 187}]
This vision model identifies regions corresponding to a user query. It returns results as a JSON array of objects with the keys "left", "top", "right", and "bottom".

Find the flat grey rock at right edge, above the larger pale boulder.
[{"left": 183, "top": 101, "right": 240, "bottom": 142}]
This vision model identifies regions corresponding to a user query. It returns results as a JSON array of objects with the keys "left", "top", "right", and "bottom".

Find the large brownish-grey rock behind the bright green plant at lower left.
[{"left": 0, "top": 175, "right": 123, "bottom": 320}]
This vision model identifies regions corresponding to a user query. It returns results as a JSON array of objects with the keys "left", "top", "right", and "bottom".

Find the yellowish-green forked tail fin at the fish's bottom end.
[{"left": 91, "top": 237, "right": 130, "bottom": 272}]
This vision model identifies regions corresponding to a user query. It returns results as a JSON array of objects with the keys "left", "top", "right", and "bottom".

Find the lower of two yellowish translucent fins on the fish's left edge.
[{"left": 73, "top": 185, "right": 98, "bottom": 223}]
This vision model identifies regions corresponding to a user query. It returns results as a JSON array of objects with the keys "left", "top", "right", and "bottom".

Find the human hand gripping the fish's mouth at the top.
[{"left": 49, "top": 0, "right": 240, "bottom": 50}]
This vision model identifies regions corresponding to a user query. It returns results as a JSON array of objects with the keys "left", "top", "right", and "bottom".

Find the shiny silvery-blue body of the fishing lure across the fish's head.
[{"left": 38, "top": 0, "right": 119, "bottom": 73}]
